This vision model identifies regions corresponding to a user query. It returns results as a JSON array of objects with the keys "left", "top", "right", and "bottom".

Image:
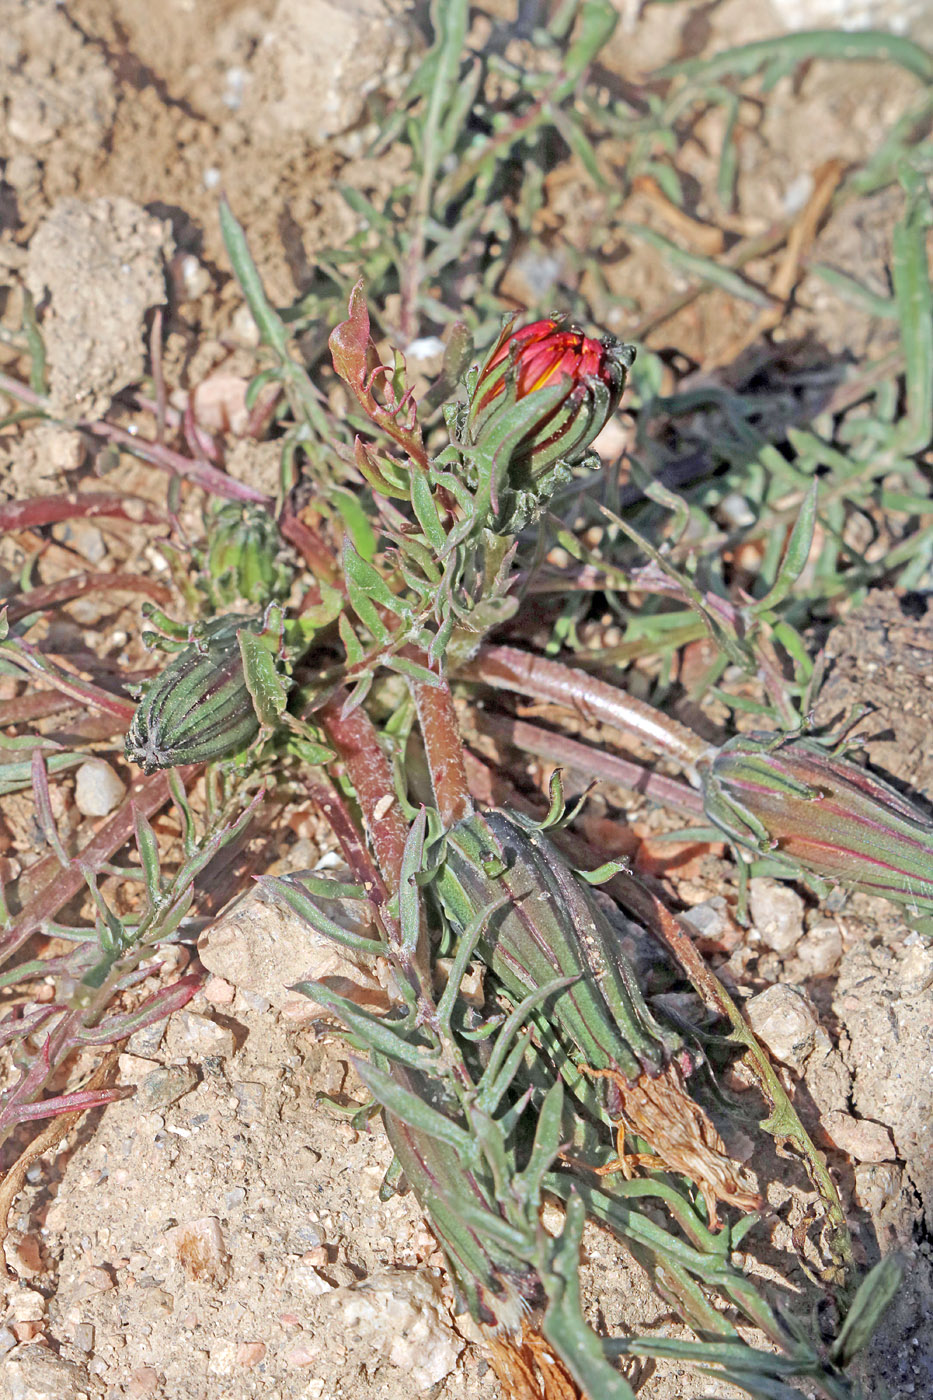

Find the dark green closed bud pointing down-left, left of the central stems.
[{"left": 125, "top": 615, "right": 262, "bottom": 773}]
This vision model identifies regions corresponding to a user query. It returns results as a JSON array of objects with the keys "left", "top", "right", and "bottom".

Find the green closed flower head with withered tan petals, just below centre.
[{"left": 434, "top": 811, "right": 759, "bottom": 1225}]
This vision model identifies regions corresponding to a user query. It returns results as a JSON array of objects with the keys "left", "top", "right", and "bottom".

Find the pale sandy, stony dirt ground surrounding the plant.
[{"left": 0, "top": 0, "right": 933, "bottom": 1400}]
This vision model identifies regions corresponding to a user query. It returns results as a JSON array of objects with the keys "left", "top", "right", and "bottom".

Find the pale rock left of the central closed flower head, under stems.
[{"left": 198, "top": 893, "right": 388, "bottom": 1019}]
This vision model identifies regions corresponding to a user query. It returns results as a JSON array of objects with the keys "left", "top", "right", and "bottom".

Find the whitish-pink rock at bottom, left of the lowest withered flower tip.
[{"left": 332, "top": 1270, "right": 465, "bottom": 1393}]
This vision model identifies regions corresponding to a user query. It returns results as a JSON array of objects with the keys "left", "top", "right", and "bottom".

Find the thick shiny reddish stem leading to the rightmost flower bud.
[{"left": 458, "top": 647, "right": 709, "bottom": 776}]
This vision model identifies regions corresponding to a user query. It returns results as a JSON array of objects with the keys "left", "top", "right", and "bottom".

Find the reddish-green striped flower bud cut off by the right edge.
[{"left": 703, "top": 734, "right": 933, "bottom": 916}]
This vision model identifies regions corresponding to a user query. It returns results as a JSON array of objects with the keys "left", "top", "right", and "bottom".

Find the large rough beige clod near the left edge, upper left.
[{"left": 25, "top": 197, "right": 171, "bottom": 417}]
